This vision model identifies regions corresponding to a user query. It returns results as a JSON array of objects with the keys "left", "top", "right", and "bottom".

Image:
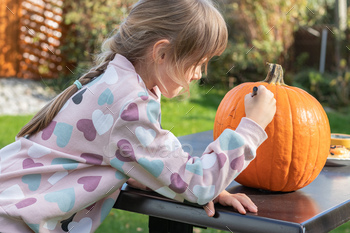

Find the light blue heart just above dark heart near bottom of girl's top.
[{"left": 44, "top": 188, "right": 75, "bottom": 212}]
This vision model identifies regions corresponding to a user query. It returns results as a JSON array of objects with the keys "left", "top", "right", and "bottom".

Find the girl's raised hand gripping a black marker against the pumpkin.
[{"left": 244, "top": 85, "right": 276, "bottom": 129}]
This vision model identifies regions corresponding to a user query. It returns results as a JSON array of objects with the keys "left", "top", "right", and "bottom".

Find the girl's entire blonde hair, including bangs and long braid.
[{"left": 17, "top": 0, "right": 228, "bottom": 137}]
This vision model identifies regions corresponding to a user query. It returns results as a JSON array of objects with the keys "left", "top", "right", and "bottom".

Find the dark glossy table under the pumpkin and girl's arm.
[{"left": 114, "top": 131, "right": 350, "bottom": 233}]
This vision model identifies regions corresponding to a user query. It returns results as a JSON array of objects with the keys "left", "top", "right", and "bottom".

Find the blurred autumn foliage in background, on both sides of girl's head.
[{"left": 55, "top": 0, "right": 350, "bottom": 108}]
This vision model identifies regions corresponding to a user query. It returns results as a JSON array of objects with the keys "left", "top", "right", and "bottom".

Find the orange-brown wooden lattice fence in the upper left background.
[{"left": 0, "top": 0, "right": 63, "bottom": 79}]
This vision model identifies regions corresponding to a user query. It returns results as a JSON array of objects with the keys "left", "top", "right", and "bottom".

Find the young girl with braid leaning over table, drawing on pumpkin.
[{"left": 0, "top": 0, "right": 275, "bottom": 233}]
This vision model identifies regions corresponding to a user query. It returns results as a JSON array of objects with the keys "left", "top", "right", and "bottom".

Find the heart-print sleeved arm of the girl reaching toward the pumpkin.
[{"left": 105, "top": 94, "right": 267, "bottom": 205}]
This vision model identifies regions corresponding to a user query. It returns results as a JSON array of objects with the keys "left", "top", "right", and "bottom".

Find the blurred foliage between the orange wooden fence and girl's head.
[{"left": 50, "top": 0, "right": 136, "bottom": 91}]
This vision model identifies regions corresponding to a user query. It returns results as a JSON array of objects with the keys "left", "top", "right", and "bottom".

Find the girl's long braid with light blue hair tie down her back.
[{"left": 17, "top": 51, "right": 116, "bottom": 137}]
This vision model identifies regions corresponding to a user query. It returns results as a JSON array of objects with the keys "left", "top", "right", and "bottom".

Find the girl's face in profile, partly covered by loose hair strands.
[{"left": 157, "top": 61, "right": 205, "bottom": 98}]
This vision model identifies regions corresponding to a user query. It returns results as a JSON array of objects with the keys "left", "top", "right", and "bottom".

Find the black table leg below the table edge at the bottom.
[{"left": 148, "top": 216, "right": 193, "bottom": 233}]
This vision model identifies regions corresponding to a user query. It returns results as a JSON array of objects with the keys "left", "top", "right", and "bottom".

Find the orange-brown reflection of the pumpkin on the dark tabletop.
[{"left": 227, "top": 185, "right": 320, "bottom": 223}]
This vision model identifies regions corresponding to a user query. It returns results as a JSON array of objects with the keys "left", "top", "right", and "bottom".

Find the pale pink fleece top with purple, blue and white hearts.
[{"left": 0, "top": 55, "right": 267, "bottom": 233}]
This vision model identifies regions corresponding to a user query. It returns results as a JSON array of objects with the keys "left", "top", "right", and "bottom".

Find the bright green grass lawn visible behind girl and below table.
[{"left": 0, "top": 84, "right": 350, "bottom": 233}]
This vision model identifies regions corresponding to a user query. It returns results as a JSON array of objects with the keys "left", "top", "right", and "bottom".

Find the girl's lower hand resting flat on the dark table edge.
[{"left": 204, "top": 190, "right": 258, "bottom": 217}]
